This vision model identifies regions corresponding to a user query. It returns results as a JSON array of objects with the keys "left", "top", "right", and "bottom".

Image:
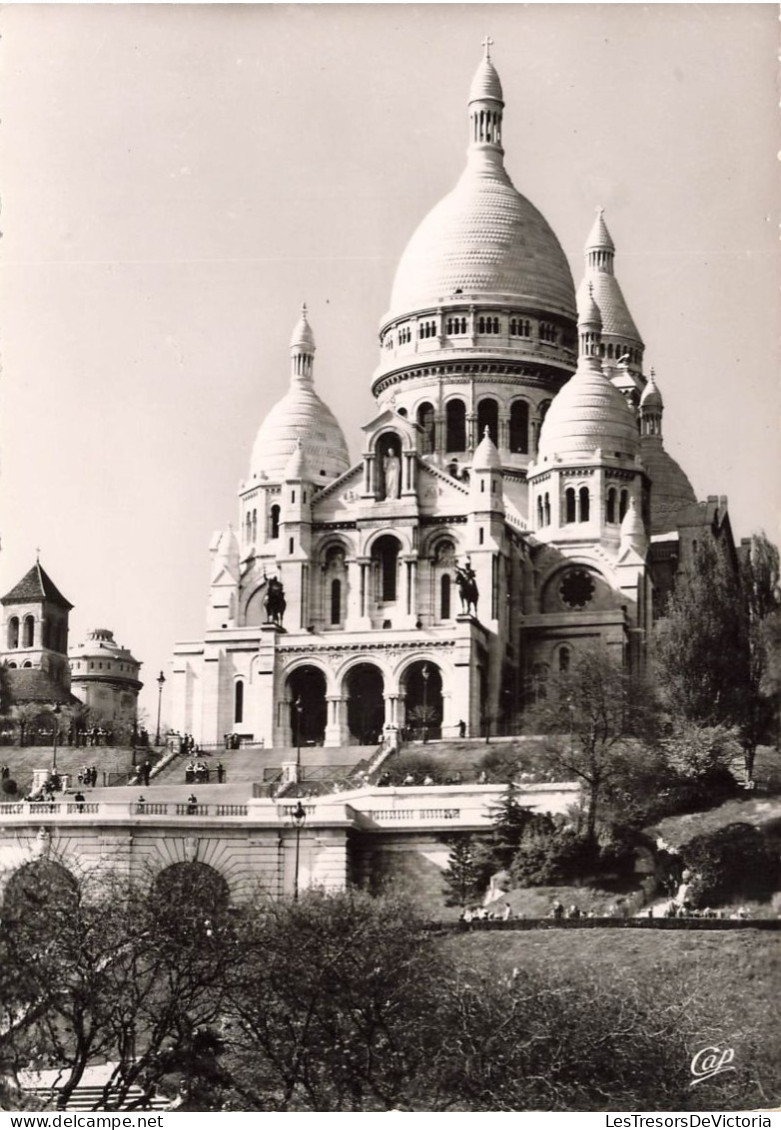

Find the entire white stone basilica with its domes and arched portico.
[{"left": 173, "top": 41, "right": 714, "bottom": 748}]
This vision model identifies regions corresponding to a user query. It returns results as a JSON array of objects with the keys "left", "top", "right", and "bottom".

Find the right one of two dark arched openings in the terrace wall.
[{"left": 149, "top": 860, "right": 231, "bottom": 945}]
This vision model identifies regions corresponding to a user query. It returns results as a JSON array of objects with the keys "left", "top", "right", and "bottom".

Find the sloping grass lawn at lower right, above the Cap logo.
[{"left": 440, "top": 928, "right": 781, "bottom": 1109}]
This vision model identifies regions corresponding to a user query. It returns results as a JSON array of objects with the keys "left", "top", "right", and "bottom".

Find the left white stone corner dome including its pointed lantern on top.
[{"left": 246, "top": 307, "right": 349, "bottom": 487}]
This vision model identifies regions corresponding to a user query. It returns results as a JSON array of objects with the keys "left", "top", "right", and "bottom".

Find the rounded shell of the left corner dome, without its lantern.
[{"left": 246, "top": 382, "right": 349, "bottom": 487}]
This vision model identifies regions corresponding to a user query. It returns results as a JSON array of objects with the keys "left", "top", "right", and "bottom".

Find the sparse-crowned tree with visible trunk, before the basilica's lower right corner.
[{"left": 527, "top": 646, "right": 657, "bottom": 840}]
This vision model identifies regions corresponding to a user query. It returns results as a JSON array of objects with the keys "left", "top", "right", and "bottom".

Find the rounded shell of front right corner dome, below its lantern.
[{"left": 538, "top": 357, "right": 640, "bottom": 461}]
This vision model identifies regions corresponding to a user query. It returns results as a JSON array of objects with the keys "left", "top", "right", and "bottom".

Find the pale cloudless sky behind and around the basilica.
[{"left": 0, "top": 3, "right": 781, "bottom": 722}]
